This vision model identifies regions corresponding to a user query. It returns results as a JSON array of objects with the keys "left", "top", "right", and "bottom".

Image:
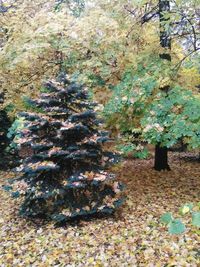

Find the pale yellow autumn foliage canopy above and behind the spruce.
[{"left": 0, "top": 0, "right": 200, "bottom": 108}]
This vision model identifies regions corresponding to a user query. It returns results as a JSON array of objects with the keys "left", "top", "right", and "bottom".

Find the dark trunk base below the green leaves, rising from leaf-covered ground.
[{"left": 154, "top": 144, "right": 170, "bottom": 171}]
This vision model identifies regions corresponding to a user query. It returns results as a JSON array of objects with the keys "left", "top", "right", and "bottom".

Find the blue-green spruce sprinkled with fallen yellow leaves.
[{"left": 9, "top": 77, "right": 122, "bottom": 222}]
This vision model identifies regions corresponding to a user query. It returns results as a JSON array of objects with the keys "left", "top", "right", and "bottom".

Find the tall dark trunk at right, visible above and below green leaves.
[{"left": 154, "top": 0, "right": 171, "bottom": 171}]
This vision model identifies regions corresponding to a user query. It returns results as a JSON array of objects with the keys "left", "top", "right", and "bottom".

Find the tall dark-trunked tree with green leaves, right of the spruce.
[{"left": 103, "top": 1, "right": 200, "bottom": 170}]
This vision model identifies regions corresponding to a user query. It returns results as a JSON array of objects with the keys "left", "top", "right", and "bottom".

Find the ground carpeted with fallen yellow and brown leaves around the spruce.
[{"left": 0, "top": 152, "right": 200, "bottom": 267}]
